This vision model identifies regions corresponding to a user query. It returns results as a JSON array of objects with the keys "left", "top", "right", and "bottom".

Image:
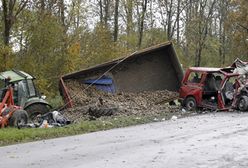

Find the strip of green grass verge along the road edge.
[{"left": 0, "top": 113, "right": 186, "bottom": 146}]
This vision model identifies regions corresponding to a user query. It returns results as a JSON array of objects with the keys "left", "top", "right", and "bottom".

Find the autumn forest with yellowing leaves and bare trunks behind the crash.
[{"left": 0, "top": 0, "right": 248, "bottom": 97}]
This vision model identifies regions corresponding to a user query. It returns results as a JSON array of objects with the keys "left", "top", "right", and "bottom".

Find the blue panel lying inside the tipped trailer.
[{"left": 83, "top": 76, "right": 115, "bottom": 93}]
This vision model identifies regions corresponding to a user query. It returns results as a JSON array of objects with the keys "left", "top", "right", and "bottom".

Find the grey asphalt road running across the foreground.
[{"left": 0, "top": 112, "right": 248, "bottom": 168}]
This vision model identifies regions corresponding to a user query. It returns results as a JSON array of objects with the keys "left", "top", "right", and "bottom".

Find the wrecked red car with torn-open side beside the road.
[{"left": 179, "top": 66, "right": 248, "bottom": 111}]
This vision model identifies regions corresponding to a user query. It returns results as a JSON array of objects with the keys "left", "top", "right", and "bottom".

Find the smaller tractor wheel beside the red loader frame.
[{"left": 9, "top": 110, "right": 28, "bottom": 127}]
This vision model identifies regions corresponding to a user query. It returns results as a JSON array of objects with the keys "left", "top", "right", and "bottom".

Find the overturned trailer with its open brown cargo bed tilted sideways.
[{"left": 59, "top": 42, "right": 183, "bottom": 107}]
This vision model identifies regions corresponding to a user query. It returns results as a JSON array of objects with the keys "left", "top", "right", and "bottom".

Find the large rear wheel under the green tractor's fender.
[{"left": 25, "top": 104, "right": 50, "bottom": 121}]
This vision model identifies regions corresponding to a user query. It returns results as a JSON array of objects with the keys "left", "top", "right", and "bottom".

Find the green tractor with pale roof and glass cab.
[{"left": 0, "top": 70, "right": 52, "bottom": 120}]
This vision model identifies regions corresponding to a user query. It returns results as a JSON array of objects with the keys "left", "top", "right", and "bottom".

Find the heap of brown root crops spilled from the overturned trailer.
[{"left": 64, "top": 81, "right": 179, "bottom": 121}]
